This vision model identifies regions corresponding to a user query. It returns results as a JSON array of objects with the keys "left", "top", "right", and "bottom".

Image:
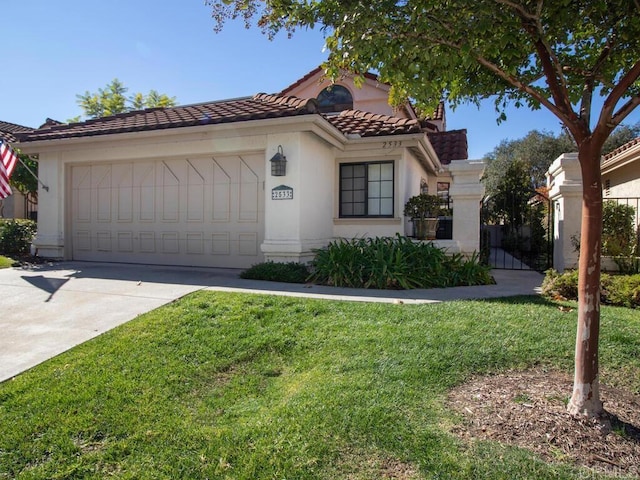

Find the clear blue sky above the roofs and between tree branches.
[{"left": 0, "top": 0, "right": 640, "bottom": 159}]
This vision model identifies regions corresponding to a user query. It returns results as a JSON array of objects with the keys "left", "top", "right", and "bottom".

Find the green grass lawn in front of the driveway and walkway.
[{"left": 0, "top": 292, "right": 640, "bottom": 480}]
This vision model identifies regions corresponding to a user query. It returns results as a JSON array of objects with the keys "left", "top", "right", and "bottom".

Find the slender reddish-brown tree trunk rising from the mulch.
[{"left": 568, "top": 141, "right": 603, "bottom": 417}]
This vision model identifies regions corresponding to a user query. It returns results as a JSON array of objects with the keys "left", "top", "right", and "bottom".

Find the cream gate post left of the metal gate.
[{"left": 449, "top": 160, "right": 486, "bottom": 254}]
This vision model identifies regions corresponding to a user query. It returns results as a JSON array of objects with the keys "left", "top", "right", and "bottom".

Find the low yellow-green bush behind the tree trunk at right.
[{"left": 542, "top": 270, "right": 640, "bottom": 308}]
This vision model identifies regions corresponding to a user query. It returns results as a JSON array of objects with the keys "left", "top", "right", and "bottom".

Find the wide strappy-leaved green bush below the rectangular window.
[{"left": 311, "top": 235, "right": 492, "bottom": 289}]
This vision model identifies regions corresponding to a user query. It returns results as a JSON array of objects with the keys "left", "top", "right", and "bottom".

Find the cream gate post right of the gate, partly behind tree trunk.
[{"left": 547, "top": 153, "right": 582, "bottom": 272}]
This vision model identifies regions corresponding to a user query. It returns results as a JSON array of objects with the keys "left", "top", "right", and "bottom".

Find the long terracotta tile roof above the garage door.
[{"left": 19, "top": 93, "right": 318, "bottom": 142}]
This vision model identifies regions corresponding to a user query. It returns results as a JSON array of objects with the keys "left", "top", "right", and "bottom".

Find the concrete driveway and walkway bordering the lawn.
[{"left": 0, "top": 262, "right": 543, "bottom": 382}]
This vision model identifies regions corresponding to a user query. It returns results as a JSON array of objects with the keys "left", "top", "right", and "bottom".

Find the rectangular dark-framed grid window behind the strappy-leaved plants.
[{"left": 340, "top": 162, "right": 393, "bottom": 217}]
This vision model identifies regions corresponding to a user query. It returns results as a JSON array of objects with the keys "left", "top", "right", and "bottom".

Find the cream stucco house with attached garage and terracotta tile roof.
[{"left": 15, "top": 69, "right": 482, "bottom": 268}]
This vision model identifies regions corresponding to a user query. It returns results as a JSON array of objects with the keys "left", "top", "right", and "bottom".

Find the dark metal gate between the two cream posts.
[{"left": 480, "top": 191, "right": 553, "bottom": 272}]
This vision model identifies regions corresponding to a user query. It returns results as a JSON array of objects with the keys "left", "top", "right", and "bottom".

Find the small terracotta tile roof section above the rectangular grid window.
[{"left": 325, "top": 110, "right": 422, "bottom": 137}]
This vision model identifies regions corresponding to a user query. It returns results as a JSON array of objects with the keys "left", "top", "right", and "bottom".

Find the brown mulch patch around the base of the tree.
[{"left": 448, "top": 371, "right": 640, "bottom": 477}]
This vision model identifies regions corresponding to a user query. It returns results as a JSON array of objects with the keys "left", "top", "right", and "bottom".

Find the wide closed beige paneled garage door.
[{"left": 70, "top": 155, "right": 264, "bottom": 268}]
